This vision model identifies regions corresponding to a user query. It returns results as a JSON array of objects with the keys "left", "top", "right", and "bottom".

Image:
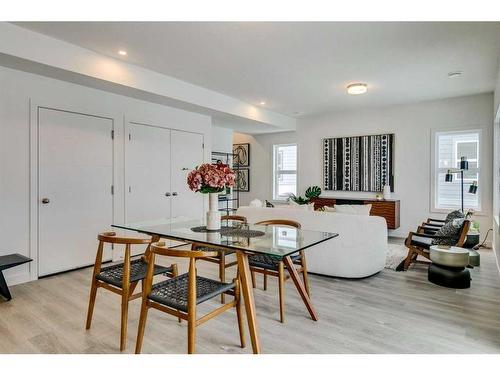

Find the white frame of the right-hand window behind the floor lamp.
[{"left": 429, "top": 128, "right": 485, "bottom": 215}]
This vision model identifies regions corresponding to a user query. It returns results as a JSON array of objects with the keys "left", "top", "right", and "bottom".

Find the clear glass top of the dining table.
[{"left": 112, "top": 218, "right": 338, "bottom": 257}]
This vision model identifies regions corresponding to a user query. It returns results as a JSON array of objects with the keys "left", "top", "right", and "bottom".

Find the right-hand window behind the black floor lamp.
[{"left": 433, "top": 130, "right": 481, "bottom": 211}]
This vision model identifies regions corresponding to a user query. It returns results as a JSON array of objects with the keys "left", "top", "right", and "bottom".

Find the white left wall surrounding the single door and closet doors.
[{"left": 0, "top": 67, "right": 212, "bottom": 284}]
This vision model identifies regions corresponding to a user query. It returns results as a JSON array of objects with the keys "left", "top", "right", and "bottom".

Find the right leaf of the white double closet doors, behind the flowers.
[{"left": 171, "top": 130, "right": 203, "bottom": 220}]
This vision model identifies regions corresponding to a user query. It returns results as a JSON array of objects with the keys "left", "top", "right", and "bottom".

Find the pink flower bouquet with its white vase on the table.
[{"left": 187, "top": 162, "right": 236, "bottom": 230}]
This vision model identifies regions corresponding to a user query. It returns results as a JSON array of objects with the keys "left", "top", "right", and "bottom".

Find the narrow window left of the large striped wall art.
[{"left": 273, "top": 144, "right": 297, "bottom": 200}]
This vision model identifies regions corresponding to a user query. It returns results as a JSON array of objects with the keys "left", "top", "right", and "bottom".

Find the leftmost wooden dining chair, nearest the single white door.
[{"left": 86, "top": 232, "right": 177, "bottom": 351}]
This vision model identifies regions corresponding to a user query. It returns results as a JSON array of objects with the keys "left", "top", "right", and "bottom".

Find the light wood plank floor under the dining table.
[{"left": 0, "top": 245, "right": 500, "bottom": 353}]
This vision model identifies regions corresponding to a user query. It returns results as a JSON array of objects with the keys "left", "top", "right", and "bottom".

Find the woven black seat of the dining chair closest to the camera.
[{"left": 148, "top": 273, "right": 235, "bottom": 312}]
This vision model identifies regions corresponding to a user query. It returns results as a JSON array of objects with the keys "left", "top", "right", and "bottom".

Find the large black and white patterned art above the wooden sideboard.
[{"left": 323, "top": 134, "right": 394, "bottom": 192}]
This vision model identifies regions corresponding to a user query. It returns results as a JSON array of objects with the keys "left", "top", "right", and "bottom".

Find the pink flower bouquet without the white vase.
[{"left": 187, "top": 162, "right": 236, "bottom": 194}]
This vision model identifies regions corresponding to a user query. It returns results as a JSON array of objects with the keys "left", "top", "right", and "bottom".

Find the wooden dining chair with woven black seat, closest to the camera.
[{"left": 135, "top": 242, "right": 245, "bottom": 354}]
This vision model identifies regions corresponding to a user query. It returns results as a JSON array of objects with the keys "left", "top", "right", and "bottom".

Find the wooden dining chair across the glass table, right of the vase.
[{"left": 248, "top": 219, "right": 310, "bottom": 323}]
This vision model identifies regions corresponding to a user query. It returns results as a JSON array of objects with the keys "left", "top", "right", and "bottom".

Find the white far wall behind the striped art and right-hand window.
[{"left": 297, "top": 94, "right": 493, "bottom": 236}]
